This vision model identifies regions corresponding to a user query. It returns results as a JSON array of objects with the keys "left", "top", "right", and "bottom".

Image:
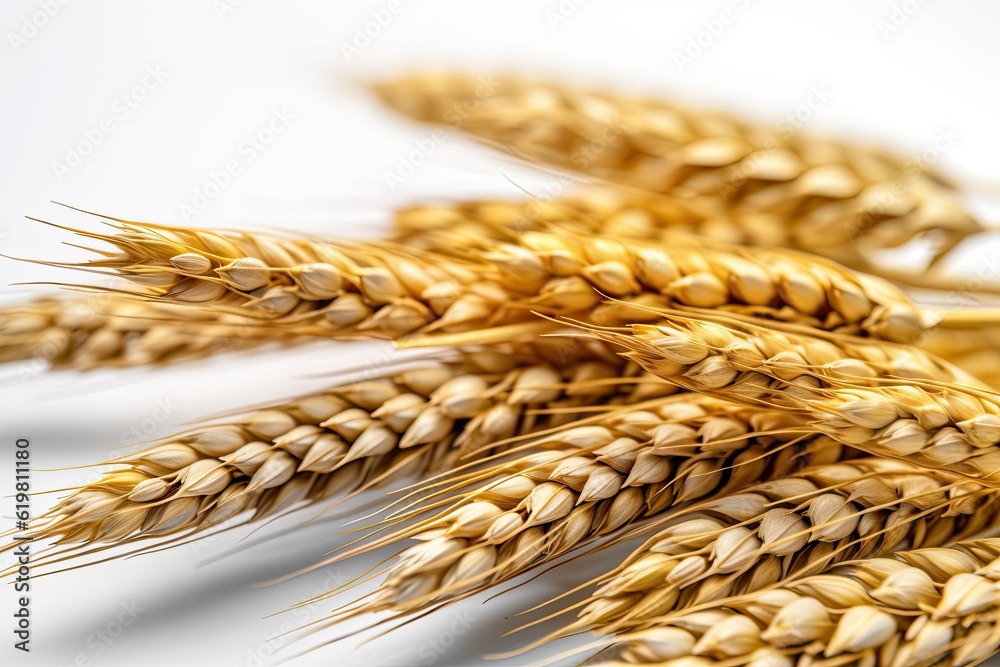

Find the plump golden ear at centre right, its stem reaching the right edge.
[{"left": 478, "top": 232, "right": 977, "bottom": 341}]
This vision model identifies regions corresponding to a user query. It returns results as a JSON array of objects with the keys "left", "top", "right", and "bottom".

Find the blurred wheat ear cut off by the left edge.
[{"left": 0, "top": 295, "right": 301, "bottom": 370}]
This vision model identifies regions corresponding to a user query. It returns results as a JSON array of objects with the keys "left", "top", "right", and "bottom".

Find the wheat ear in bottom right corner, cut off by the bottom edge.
[{"left": 588, "top": 539, "right": 1000, "bottom": 667}]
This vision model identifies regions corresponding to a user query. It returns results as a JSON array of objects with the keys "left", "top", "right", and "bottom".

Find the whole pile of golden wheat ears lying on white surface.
[{"left": 0, "top": 74, "right": 1000, "bottom": 667}]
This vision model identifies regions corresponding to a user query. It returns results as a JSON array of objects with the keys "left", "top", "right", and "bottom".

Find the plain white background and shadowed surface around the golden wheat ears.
[{"left": 0, "top": 0, "right": 1000, "bottom": 667}]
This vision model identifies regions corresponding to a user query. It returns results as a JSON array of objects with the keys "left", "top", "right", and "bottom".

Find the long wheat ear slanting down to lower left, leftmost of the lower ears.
[{"left": 13, "top": 345, "right": 672, "bottom": 568}]
